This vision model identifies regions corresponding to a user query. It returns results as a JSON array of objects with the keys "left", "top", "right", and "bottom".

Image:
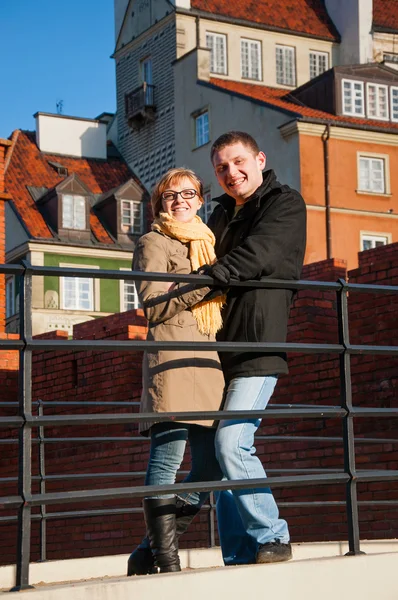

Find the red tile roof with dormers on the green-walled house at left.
[{"left": 5, "top": 130, "right": 137, "bottom": 244}]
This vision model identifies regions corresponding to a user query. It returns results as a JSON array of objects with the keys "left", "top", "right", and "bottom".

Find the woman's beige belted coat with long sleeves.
[{"left": 133, "top": 231, "right": 224, "bottom": 435}]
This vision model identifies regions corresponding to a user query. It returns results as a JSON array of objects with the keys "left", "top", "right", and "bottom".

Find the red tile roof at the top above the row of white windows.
[{"left": 191, "top": 0, "right": 340, "bottom": 41}]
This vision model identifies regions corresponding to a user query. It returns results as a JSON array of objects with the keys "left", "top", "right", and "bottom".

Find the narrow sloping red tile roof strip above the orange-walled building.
[{"left": 210, "top": 77, "right": 398, "bottom": 133}]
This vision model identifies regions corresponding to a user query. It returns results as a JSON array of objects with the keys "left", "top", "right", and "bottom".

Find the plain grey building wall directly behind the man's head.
[{"left": 175, "top": 52, "right": 300, "bottom": 196}]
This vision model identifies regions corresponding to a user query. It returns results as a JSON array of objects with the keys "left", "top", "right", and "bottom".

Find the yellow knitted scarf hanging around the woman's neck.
[{"left": 152, "top": 212, "right": 226, "bottom": 335}]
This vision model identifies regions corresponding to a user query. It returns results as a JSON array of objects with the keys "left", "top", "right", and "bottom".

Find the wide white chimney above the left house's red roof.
[{"left": 33, "top": 112, "right": 106, "bottom": 159}]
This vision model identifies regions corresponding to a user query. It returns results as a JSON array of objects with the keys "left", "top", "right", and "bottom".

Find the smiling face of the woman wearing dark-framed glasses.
[{"left": 162, "top": 177, "right": 203, "bottom": 223}]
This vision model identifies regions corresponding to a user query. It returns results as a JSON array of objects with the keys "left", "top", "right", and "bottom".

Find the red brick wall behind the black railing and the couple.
[{"left": 0, "top": 244, "right": 398, "bottom": 563}]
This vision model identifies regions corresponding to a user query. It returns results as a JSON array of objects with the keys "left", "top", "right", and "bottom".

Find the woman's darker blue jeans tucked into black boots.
[{"left": 145, "top": 422, "right": 223, "bottom": 508}]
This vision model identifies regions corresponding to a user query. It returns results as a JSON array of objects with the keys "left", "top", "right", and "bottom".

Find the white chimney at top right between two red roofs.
[{"left": 325, "top": 0, "right": 373, "bottom": 65}]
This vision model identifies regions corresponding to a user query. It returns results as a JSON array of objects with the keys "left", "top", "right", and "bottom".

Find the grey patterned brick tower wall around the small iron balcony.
[{"left": 116, "top": 15, "right": 176, "bottom": 190}]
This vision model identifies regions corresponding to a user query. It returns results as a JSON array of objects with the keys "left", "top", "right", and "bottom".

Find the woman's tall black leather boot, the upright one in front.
[{"left": 143, "top": 498, "right": 181, "bottom": 573}]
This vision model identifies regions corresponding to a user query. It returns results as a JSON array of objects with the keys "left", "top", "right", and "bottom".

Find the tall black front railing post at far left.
[{"left": 12, "top": 261, "right": 32, "bottom": 591}]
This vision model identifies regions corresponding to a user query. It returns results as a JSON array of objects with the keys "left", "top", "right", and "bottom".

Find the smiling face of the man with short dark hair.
[{"left": 213, "top": 142, "right": 266, "bottom": 204}]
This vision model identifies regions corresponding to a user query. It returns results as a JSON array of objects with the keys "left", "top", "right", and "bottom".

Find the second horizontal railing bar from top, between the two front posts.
[{"left": 26, "top": 338, "right": 344, "bottom": 354}]
